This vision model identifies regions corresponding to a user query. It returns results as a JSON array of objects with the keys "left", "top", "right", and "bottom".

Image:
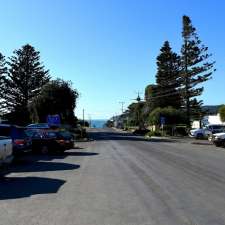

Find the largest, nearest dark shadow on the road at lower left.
[{"left": 0, "top": 177, "right": 65, "bottom": 200}]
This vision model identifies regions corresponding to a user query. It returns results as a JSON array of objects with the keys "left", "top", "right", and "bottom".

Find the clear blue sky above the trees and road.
[{"left": 0, "top": 0, "right": 225, "bottom": 119}]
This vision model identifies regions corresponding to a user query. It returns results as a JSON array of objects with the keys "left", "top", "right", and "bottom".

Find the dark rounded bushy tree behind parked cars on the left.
[{"left": 29, "top": 79, "right": 78, "bottom": 125}]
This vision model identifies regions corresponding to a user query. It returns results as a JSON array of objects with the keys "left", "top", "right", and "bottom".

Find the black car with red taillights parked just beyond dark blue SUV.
[{"left": 26, "top": 129, "right": 72, "bottom": 154}]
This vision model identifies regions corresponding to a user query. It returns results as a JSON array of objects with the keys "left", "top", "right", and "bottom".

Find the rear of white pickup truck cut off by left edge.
[{"left": 0, "top": 136, "right": 13, "bottom": 170}]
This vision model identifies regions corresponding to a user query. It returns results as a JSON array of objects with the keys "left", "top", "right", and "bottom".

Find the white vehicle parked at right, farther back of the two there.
[{"left": 190, "top": 124, "right": 225, "bottom": 139}]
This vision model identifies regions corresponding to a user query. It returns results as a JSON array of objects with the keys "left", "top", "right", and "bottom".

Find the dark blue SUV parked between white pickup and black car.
[{"left": 0, "top": 124, "right": 32, "bottom": 155}]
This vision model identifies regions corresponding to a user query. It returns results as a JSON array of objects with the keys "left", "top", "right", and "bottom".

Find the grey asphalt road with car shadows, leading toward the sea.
[{"left": 0, "top": 129, "right": 225, "bottom": 225}]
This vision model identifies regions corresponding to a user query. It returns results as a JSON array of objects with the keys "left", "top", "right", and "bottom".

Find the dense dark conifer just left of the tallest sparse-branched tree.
[{"left": 155, "top": 41, "right": 181, "bottom": 109}]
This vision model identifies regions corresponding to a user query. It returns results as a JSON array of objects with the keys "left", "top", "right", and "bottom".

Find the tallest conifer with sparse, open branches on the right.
[{"left": 180, "top": 16, "right": 215, "bottom": 126}]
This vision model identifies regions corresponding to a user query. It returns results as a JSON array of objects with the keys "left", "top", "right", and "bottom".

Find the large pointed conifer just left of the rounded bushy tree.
[{"left": 2, "top": 44, "right": 50, "bottom": 124}]
